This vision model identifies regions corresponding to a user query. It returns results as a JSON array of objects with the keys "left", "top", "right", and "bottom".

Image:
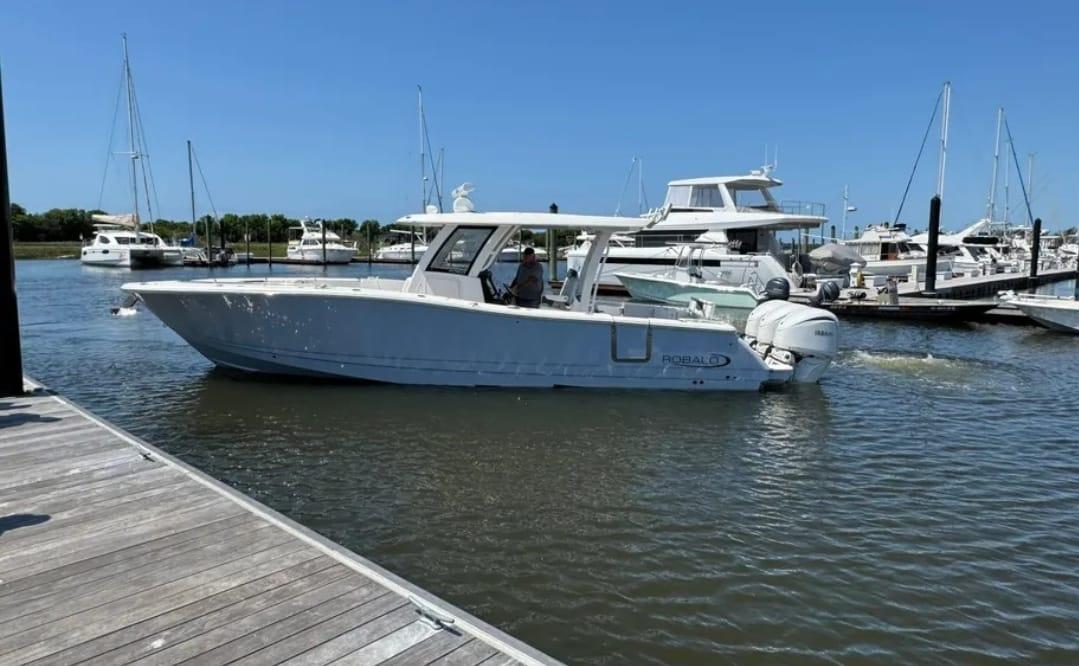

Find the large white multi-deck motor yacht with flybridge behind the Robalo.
[{"left": 566, "top": 167, "right": 828, "bottom": 288}]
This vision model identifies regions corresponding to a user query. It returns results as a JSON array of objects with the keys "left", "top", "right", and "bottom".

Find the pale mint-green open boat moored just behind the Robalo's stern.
[{"left": 615, "top": 243, "right": 763, "bottom": 325}]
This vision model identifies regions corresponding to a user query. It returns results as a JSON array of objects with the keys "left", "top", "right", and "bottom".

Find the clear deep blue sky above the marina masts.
[{"left": 0, "top": 1, "right": 1079, "bottom": 228}]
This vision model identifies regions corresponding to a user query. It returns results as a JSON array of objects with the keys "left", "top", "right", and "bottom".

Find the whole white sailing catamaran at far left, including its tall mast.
[{"left": 81, "top": 33, "right": 183, "bottom": 268}]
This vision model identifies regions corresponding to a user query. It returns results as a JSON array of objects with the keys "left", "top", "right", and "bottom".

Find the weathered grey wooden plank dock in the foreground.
[{"left": 0, "top": 388, "right": 557, "bottom": 666}]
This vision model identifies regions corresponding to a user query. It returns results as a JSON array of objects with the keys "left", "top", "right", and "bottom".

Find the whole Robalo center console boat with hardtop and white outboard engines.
[{"left": 123, "top": 185, "right": 838, "bottom": 391}]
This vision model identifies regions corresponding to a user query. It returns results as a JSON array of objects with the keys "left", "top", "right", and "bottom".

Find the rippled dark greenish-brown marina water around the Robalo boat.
[{"left": 10, "top": 261, "right": 1079, "bottom": 664}]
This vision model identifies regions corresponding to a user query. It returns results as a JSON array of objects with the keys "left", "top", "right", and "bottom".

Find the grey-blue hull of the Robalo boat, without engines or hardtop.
[{"left": 130, "top": 283, "right": 792, "bottom": 391}]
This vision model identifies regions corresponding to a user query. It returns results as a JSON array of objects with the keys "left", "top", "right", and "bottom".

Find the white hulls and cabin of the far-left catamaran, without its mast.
[{"left": 79, "top": 215, "right": 183, "bottom": 269}]
